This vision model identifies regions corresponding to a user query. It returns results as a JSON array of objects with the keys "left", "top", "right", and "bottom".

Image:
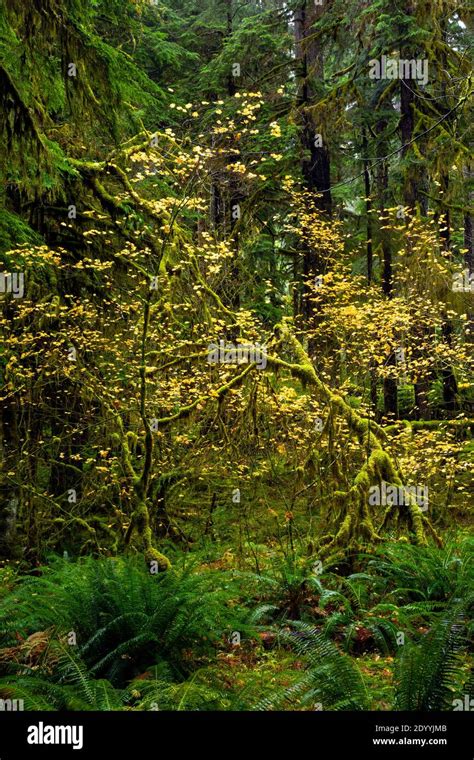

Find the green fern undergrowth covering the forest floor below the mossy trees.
[{"left": 0, "top": 538, "right": 474, "bottom": 711}]
